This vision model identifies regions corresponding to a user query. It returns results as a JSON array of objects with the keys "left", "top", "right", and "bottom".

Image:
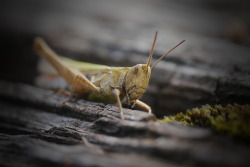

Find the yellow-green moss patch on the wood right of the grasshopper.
[{"left": 158, "top": 104, "right": 250, "bottom": 139}]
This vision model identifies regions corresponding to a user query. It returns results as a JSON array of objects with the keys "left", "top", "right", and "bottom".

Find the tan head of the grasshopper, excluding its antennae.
[{"left": 124, "top": 64, "right": 151, "bottom": 102}]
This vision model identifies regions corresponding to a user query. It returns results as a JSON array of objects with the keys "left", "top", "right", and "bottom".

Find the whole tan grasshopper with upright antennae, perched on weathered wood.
[{"left": 34, "top": 31, "right": 185, "bottom": 119}]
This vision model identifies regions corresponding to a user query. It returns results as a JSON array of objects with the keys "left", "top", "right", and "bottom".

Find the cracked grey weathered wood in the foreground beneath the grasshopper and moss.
[{"left": 0, "top": 81, "right": 250, "bottom": 166}]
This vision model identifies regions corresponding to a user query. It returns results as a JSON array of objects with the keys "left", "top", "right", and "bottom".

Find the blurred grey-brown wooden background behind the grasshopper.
[{"left": 0, "top": 0, "right": 250, "bottom": 117}]
